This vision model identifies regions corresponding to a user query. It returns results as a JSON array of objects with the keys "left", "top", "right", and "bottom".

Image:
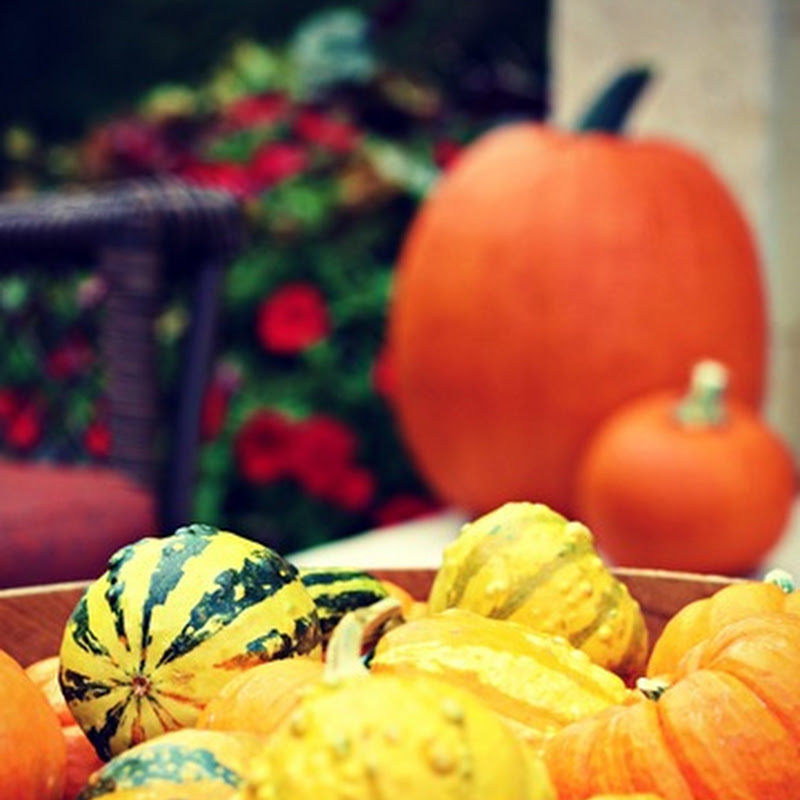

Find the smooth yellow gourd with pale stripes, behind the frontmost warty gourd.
[{"left": 370, "top": 608, "right": 632, "bottom": 752}]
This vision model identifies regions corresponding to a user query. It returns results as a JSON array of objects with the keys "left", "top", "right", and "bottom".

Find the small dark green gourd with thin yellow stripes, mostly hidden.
[{"left": 300, "top": 567, "right": 389, "bottom": 640}]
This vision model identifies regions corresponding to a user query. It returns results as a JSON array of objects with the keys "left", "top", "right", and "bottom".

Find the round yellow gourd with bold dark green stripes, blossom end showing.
[{"left": 59, "top": 525, "right": 321, "bottom": 759}]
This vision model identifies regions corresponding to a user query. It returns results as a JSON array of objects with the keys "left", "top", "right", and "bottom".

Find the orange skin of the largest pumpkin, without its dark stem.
[{"left": 387, "top": 123, "right": 766, "bottom": 517}]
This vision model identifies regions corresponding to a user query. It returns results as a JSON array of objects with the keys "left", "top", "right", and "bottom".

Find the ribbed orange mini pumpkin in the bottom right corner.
[{"left": 545, "top": 612, "right": 800, "bottom": 800}]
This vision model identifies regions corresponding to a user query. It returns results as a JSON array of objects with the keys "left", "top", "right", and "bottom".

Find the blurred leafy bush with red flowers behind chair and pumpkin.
[{"left": 0, "top": 0, "right": 546, "bottom": 552}]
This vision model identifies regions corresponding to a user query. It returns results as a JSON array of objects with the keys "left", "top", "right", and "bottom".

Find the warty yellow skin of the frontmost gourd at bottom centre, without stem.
[{"left": 247, "top": 674, "right": 556, "bottom": 800}]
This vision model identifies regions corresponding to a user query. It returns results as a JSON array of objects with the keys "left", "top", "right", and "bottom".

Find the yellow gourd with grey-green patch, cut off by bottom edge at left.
[{"left": 77, "top": 728, "right": 263, "bottom": 800}]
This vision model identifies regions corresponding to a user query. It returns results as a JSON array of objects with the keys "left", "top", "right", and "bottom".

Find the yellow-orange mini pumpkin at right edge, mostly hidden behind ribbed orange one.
[{"left": 647, "top": 581, "right": 800, "bottom": 677}]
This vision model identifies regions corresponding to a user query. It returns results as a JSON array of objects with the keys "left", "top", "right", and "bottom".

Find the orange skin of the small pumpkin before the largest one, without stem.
[{"left": 576, "top": 392, "right": 797, "bottom": 575}]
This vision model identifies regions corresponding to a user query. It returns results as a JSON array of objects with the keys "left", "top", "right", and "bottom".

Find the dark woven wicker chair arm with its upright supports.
[{"left": 0, "top": 179, "right": 243, "bottom": 578}]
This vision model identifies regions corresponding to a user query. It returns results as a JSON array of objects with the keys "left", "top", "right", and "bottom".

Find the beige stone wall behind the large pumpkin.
[{"left": 551, "top": 0, "right": 800, "bottom": 453}]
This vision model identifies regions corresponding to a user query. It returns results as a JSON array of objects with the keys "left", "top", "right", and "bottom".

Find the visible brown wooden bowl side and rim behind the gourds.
[{"left": 0, "top": 568, "right": 732, "bottom": 666}]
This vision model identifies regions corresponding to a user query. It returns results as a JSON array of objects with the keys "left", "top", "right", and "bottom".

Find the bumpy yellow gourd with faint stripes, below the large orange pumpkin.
[{"left": 428, "top": 502, "right": 648, "bottom": 679}]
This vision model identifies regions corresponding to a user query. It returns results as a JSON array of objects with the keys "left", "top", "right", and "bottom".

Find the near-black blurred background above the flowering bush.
[{"left": 0, "top": 0, "right": 549, "bottom": 141}]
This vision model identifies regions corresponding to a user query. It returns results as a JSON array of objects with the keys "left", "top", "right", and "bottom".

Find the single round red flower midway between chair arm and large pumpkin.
[{"left": 256, "top": 283, "right": 330, "bottom": 354}]
